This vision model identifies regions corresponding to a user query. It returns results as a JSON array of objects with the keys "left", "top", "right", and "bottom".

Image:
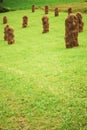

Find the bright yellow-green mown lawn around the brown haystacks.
[{"left": 0, "top": 10, "right": 87, "bottom": 130}]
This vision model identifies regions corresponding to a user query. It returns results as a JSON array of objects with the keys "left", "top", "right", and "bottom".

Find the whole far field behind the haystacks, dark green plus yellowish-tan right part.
[{"left": 2, "top": 0, "right": 87, "bottom": 13}]
